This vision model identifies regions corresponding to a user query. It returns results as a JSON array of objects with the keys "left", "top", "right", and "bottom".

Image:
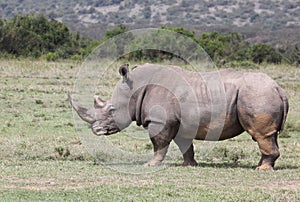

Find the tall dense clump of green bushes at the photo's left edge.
[{"left": 0, "top": 14, "right": 97, "bottom": 60}]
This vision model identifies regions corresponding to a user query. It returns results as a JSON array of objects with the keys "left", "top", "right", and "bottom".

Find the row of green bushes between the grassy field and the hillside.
[{"left": 0, "top": 14, "right": 300, "bottom": 65}]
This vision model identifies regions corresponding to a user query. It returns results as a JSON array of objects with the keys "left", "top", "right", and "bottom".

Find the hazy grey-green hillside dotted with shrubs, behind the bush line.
[{"left": 0, "top": 0, "right": 300, "bottom": 43}]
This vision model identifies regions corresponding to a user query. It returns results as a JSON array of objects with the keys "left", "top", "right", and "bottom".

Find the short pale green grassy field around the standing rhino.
[{"left": 0, "top": 60, "right": 300, "bottom": 201}]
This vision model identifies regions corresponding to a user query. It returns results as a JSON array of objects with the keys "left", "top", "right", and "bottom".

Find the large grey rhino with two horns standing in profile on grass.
[{"left": 68, "top": 63, "right": 289, "bottom": 170}]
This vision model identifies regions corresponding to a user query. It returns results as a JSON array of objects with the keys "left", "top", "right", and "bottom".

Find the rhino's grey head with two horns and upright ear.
[{"left": 68, "top": 64, "right": 132, "bottom": 135}]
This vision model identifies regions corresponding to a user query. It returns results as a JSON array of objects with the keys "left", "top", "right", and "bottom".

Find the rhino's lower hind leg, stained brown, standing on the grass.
[{"left": 256, "top": 132, "right": 280, "bottom": 170}]
